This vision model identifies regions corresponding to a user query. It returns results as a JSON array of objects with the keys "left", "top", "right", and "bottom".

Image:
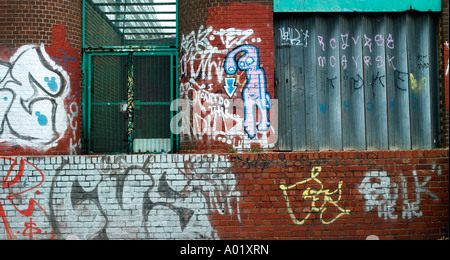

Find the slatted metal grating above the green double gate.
[{"left": 85, "top": 0, "right": 177, "bottom": 47}]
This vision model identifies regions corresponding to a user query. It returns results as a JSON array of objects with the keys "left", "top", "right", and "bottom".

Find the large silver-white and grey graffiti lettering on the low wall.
[{"left": 50, "top": 155, "right": 240, "bottom": 239}]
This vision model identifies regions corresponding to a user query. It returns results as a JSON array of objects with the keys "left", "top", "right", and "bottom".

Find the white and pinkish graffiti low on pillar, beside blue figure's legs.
[{"left": 171, "top": 92, "right": 278, "bottom": 149}]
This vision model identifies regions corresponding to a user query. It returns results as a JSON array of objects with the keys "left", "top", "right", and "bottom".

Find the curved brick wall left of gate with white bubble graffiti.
[{"left": 0, "top": 0, "right": 82, "bottom": 156}]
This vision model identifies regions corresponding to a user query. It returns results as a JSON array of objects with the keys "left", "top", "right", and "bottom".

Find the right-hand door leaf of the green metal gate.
[{"left": 133, "top": 55, "right": 173, "bottom": 153}]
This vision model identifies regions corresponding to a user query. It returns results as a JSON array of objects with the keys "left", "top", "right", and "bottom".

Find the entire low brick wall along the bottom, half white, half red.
[{"left": 0, "top": 149, "right": 449, "bottom": 240}]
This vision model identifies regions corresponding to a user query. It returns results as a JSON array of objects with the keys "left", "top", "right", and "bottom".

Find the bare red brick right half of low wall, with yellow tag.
[{"left": 216, "top": 150, "right": 449, "bottom": 240}]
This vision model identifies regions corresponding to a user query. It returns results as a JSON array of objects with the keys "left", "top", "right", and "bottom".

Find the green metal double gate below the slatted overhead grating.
[{"left": 85, "top": 51, "right": 177, "bottom": 154}]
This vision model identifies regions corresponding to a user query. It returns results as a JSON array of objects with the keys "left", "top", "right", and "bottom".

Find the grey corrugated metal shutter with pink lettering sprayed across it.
[{"left": 275, "top": 13, "right": 440, "bottom": 150}]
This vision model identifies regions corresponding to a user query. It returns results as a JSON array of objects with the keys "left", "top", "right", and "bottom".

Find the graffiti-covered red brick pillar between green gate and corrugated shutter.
[{"left": 180, "top": 1, "right": 276, "bottom": 152}]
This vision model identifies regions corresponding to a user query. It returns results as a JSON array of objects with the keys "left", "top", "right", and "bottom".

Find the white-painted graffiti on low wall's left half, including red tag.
[{"left": 0, "top": 155, "right": 241, "bottom": 240}]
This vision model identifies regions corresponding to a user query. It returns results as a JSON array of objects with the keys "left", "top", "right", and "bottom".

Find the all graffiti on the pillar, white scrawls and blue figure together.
[{"left": 179, "top": 26, "right": 276, "bottom": 149}]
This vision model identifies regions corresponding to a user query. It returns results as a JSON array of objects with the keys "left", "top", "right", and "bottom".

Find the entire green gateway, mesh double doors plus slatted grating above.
[{"left": 82, "top": 0, "right": 178, "bottom": 154}]
